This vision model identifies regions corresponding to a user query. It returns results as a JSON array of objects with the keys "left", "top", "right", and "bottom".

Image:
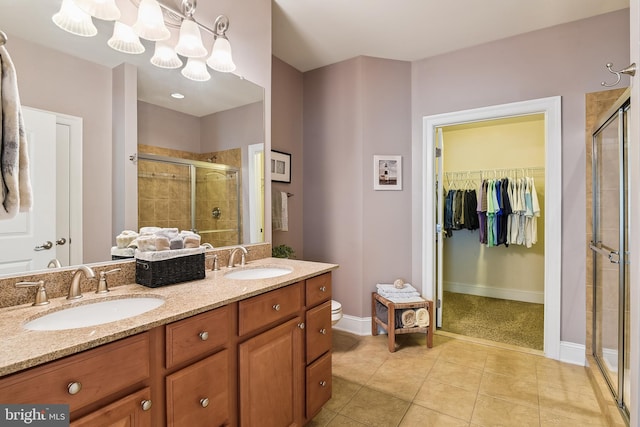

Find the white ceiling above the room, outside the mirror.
[{"left": 273, "top": 0, "right": 629, "bottom": 72}]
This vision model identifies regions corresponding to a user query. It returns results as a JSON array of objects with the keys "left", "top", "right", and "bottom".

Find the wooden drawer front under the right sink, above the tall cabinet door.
[{"left": 238, "top": 282, "right": 303, "bottom": 335}]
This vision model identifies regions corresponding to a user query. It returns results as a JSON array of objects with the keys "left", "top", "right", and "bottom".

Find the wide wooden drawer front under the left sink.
[{"left": 0, "top": 332, "right": 149, "bottom": 413}]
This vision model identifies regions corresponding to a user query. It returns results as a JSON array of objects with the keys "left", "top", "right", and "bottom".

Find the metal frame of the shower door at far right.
[{"left": 589, "top": 92, "right": 631, "bottom": 420}]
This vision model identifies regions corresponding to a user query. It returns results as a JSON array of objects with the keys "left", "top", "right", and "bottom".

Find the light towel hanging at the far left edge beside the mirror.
[{"left": 0, "top": 46, "right": 32, "bottom": 219}]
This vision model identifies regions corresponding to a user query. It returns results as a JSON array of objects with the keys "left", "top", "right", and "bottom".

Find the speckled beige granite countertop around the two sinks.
[{"left": 0, "top": 258, "right": 338, "bottom": 376}]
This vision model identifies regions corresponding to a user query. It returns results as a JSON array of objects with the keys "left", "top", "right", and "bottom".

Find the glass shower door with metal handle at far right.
[{"left": 590, "top": 101, "right": 630, "bottom": 416}]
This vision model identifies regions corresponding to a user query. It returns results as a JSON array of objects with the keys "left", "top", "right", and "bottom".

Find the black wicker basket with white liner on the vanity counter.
[{"left": 136, "top": 250, "right": 205, "bottom": 288}]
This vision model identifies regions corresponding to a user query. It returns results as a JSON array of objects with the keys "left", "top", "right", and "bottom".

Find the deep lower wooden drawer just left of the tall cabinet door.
[{"left": 167, "top": 350, "right": 230, "bottom": 427}]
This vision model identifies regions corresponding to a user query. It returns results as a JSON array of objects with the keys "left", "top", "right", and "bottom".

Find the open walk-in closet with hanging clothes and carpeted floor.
[{"left": 436, "top": 114, "right": 547, "bottom": 350}]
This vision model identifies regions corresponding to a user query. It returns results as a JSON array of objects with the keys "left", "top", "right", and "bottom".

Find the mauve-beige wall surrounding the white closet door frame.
[{"left": 411, "top": 10, "right": 629, "bottom": 344}]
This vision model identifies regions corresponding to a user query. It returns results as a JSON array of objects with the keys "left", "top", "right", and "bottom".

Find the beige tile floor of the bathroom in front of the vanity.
[{"left": 307, "top": 330, "right": 610, "bottom": 427}]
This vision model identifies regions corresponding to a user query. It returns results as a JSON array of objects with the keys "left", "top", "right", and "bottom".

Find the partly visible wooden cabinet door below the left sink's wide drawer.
[{"left": 71, "top": 387, "right": 151, "bottom": 427}]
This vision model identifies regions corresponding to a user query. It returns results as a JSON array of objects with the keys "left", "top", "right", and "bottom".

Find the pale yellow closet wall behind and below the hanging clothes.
[{"left": 443, "top": 114, "right": 545, "bottom": 303}]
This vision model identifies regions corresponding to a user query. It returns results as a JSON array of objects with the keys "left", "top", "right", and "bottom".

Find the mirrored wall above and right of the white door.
[{"left": 7, "top": 37, "right": 113, "bottom": 262}]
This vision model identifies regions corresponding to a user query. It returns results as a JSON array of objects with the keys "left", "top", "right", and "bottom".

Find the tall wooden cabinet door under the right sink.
[{"left": 239, "top": 317, "right": 304, "bottom": 427}]
